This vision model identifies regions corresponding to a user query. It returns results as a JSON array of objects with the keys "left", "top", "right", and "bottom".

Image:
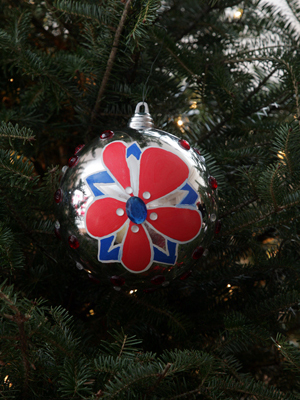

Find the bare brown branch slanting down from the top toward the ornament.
[{"left": 87, "top": 0, "right": 132, "bottom": 135}]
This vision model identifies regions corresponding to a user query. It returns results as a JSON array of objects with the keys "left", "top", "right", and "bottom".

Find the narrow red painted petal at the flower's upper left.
[{"left": 103, "top": 142, "right": 130, "bottom": 189}]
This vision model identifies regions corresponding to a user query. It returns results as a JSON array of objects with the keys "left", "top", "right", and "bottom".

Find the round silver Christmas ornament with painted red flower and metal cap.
[{"left": 54, "top": 103, "right": 217, "bottom": 290}]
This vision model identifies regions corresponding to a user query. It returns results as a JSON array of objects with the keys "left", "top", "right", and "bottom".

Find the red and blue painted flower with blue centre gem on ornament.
[{"left": 85, "top": 141, "right": 202, "bottom": 273}]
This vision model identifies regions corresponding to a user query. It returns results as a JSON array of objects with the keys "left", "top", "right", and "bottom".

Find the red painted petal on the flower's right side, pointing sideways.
[{"left": 147, "top": 207, "right": 202, "bottom": 242}]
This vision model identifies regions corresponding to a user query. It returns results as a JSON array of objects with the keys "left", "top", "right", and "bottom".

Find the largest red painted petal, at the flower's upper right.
[{"left": 139, "top": 148, "right": 189, "bottom": 203}]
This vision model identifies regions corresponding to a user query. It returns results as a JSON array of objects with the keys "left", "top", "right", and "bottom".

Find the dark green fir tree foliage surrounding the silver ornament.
[{"left": 0, "top": 0, "right": 300, "bottom": 400}]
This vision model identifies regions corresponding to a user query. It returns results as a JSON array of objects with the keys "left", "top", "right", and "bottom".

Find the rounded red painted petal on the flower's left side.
[{"left": 86, "top": 197, "right": 128, "bottom": 238}]
